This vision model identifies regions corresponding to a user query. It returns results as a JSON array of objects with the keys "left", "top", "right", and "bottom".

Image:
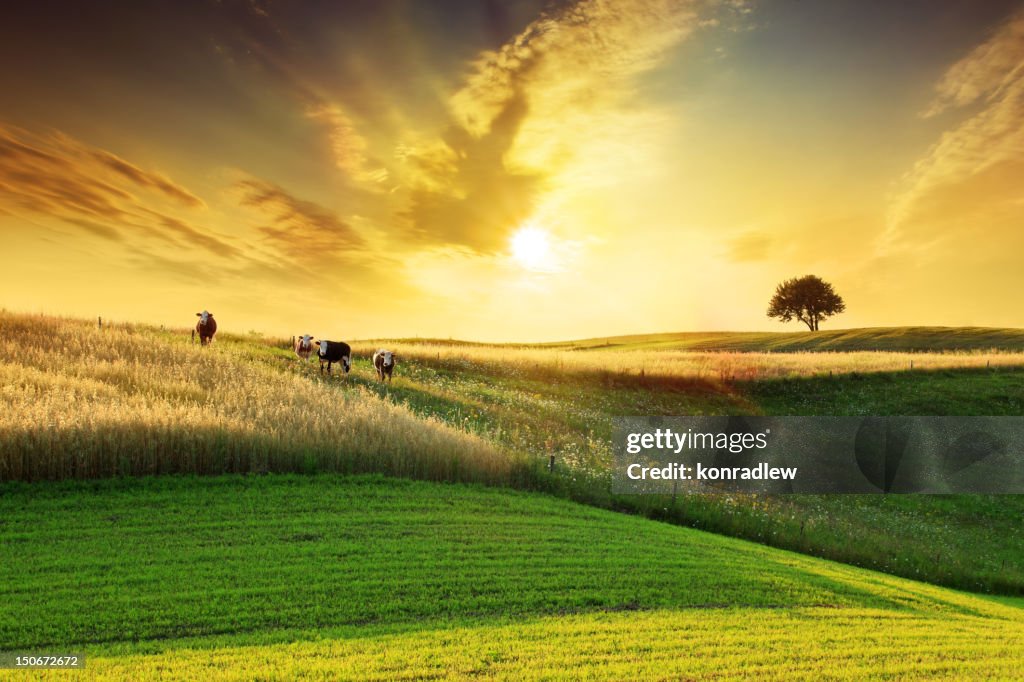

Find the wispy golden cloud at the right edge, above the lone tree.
[{"left": 889, "top": 12, "right": 1024, "bottom": 240}]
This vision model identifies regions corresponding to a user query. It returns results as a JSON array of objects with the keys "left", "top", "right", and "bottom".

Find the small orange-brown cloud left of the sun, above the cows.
[{"left": 234, "top": 178, "right": 366, "bottom": 267}]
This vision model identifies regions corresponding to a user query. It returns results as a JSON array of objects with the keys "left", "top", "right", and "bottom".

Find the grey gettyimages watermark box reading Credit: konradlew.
[{"left": 612, "top": 417, "right": 1024, "bottom": 495}]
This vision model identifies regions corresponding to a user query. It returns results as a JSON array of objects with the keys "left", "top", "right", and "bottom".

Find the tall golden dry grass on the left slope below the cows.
[{"left": 0, "top": 311, "right": 523, "bottom": 483}]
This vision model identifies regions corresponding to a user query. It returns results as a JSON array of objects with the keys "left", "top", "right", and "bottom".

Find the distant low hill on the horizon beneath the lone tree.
[{"left": 541, "top": 327, "right": 1024, "bottom": 352}]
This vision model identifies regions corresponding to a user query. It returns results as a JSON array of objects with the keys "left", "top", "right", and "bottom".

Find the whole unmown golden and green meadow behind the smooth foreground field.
[{"left": 0, "top": 313, "right": 1024, "bottom": 595}]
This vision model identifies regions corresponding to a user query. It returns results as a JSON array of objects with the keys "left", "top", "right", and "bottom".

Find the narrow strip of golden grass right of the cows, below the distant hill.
[{"left": 352, "top": 342, "right": 1024, "bottom": 382}]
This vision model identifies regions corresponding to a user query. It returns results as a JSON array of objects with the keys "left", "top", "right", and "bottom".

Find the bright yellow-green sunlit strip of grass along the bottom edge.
[{"left": 59, "top": 607, "right": 1024, "bottom": 682}]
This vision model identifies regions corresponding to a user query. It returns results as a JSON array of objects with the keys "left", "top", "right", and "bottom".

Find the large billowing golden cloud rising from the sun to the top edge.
[{"left": 392, "top": 0, "right": 713, "bottom": 253}]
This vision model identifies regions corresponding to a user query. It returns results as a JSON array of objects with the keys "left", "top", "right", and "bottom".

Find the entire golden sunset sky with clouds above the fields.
[{"left": 0, "top": 0, "right": 1024, "bottom": 341}]
